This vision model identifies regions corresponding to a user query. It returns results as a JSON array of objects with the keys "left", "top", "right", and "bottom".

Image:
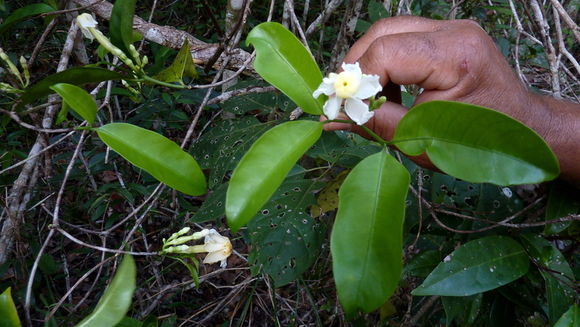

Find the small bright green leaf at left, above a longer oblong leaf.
[{"left": 50, "top": 83, "right": 97, "bottom": 125}]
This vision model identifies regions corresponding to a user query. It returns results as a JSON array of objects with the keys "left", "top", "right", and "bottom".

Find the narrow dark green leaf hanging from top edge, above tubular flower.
[{"left": 109, "top": 0, "right": 137, "bottom": 57}]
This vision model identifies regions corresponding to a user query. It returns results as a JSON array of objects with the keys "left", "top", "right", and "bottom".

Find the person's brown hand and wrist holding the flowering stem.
[{"left": 322, "top": 16, "right": 580, "bottom": 185}]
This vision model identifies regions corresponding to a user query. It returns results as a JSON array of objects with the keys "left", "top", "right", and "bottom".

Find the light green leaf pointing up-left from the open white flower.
[{"left": 246, "top": 22, "right": 324, "bottom": 115}]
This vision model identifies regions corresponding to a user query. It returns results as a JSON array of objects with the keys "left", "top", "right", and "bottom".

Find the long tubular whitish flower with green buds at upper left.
[{"left": 76, "top": 13, "right": 149, "bottom": 72}]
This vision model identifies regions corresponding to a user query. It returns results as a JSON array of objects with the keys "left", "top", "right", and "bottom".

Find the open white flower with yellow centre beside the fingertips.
[{"left": 312, "top": 62, "right": 382, "bottom": 125}]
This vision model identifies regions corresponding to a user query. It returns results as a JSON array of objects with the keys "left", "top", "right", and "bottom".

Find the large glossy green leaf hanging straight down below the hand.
[{"left": 330, "top": 152, "right": 410, "bottom": 314}]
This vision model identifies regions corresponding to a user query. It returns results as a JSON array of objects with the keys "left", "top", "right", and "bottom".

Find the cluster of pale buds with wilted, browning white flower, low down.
[{"left": 160, "top": 227, "right": 232, "bottom": 268}]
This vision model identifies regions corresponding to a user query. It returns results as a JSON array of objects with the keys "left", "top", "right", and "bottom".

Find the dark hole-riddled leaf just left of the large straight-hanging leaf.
[{"left": 248, "top": 180, "right": 324, "bottom": 287}]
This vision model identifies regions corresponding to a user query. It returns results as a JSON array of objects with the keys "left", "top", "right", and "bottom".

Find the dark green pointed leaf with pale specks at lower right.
[{"left": 411, "top": 236, "right": 529, "bottom": 296}]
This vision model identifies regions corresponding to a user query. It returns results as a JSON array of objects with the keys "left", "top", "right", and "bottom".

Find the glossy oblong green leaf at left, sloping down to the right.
[{"left": 96, "top": 123, "right": 206, "bottom": 195}]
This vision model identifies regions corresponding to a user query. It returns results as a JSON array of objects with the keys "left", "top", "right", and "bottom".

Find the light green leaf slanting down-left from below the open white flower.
[{"left": 226, "top": 120, "right": 322, "bottom": 232}]
